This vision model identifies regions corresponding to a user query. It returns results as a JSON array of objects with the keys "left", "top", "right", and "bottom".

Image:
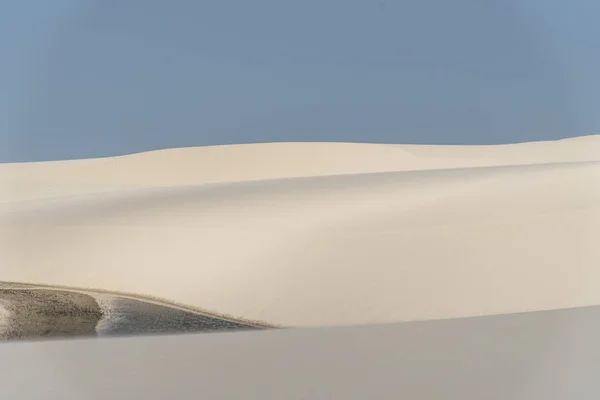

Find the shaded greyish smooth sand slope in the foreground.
[{"left": 0, "top": 307, "right": 600, "bottom": 400}]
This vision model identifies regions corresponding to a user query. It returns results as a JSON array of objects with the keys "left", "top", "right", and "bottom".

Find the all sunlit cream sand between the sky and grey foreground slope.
[{"left": 0, "top": 136, "right": 600, "bottom": 326}]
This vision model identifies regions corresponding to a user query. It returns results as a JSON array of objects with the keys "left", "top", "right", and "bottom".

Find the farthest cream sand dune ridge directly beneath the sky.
[{"left": 0, "top": 135, "right": 600, "bottom": 202}]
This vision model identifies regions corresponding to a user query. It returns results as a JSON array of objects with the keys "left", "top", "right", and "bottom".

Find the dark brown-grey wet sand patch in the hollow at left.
[{"left": 0, "top": 283, "right": 260, "bottom": 340}]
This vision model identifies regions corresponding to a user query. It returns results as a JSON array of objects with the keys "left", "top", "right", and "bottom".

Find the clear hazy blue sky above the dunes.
[{"left": 0, "top": 0, "right": 600, "bottom": 162}]
